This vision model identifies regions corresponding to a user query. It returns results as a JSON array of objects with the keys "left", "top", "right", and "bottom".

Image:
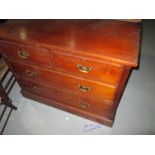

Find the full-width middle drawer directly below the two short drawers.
[{"left": 9, "top": 61, "right": 116, "bottom": 101}]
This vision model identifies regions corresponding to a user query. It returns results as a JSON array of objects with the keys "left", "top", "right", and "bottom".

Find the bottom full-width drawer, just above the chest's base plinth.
[{"left": 18, "top": 78, "right": 112, "bottom": 115}]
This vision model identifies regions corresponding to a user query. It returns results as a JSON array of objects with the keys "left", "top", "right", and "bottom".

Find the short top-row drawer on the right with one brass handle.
[{"left": 53, "top": 52, "right": 122, "bottom": 85}]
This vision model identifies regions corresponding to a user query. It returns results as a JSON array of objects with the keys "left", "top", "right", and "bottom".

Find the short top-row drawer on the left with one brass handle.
[{"left": 0, "top": 43, "right": 52, "bottom": 66}]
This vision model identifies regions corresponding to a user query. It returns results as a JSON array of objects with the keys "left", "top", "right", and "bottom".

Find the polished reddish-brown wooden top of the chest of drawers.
[{"left": 0, "top": 20, "right": 140, "bottom": 67}]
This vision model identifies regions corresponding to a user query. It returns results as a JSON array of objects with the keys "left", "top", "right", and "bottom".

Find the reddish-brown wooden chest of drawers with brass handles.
[{"left": 0, "top": 20, "right": 140, "bottom": 126}]
